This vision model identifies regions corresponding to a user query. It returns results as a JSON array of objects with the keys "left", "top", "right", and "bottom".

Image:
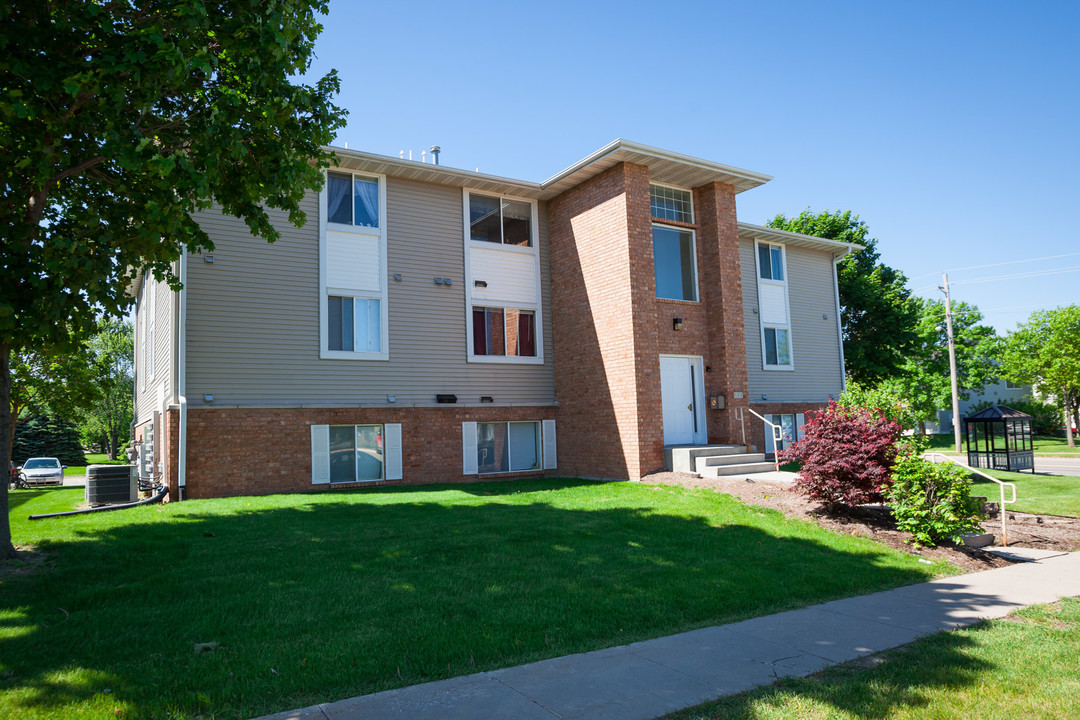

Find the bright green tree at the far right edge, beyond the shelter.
[{"left": 1001, "top": 304, "right": 1080, "bottom": 447}]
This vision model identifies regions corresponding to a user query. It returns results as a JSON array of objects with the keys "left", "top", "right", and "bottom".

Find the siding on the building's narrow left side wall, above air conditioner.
[{"left": 135, "top": 276, "right": 175, "bottom": 423}]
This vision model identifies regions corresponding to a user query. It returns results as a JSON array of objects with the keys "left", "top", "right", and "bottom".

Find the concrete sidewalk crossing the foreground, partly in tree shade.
[{"left": 264, "top": 553, "right": 1080, "bottom": 720}]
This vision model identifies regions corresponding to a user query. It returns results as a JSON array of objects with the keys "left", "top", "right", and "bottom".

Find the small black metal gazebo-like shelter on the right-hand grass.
[{"left": 963, "top": 405, "right": 1035, "bottom": 474}]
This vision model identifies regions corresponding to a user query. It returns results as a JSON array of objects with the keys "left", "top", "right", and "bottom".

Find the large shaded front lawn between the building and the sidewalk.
[{"left": 0, "top": 480, "right": 956, "bottom": 720}]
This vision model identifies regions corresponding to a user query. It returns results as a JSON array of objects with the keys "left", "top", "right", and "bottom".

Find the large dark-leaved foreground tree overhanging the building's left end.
[{"left": 0, "top": 0, "right": 343, "bottom": 557}]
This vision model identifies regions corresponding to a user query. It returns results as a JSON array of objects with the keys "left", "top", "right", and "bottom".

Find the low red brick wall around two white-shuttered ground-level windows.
[{"left": 185, "top": 406, "right": 552, "bottom": 499}]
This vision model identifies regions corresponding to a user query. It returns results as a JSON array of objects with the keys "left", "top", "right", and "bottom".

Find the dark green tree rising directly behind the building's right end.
[{"left": 768, "top": 208, "right": 918, "bottom": 385}]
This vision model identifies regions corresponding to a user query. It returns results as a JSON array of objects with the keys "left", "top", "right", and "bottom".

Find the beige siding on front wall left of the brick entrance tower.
[{"left": 187, "top": 177, "right": 554, "bottom": 407}]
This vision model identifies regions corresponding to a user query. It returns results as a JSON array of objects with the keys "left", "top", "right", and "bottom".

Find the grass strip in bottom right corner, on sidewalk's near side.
[{"left": 667, "top": 599, "right": 1080, "bottom": 720}]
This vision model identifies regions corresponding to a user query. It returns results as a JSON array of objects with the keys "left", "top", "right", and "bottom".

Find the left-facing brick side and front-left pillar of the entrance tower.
[{"left": 548, "top": 164, "right": 659, "bottom": 479}]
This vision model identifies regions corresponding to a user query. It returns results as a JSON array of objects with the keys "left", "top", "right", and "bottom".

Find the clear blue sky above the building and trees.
[{"left": 310, "top": 0, "right": 1080, "bottom": 332}]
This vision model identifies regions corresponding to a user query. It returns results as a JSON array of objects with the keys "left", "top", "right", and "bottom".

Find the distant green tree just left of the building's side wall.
[{"left": 79, "top": 318, "right": 135, "bottom": 460}]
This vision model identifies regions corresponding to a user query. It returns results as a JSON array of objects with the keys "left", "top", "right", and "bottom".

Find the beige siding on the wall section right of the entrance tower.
[{"left": 739, "top": 239, "right": 843, "bottom": 403}]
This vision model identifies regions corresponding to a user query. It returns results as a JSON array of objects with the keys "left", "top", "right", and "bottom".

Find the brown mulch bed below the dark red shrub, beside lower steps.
[{"left": 642, "top": 473, "right": 1080, "bottom": 572}]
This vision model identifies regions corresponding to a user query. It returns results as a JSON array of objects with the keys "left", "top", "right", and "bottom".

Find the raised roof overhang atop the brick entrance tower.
[{"left": 541, "top": 139, "right": 772, "bottom": 198}]
